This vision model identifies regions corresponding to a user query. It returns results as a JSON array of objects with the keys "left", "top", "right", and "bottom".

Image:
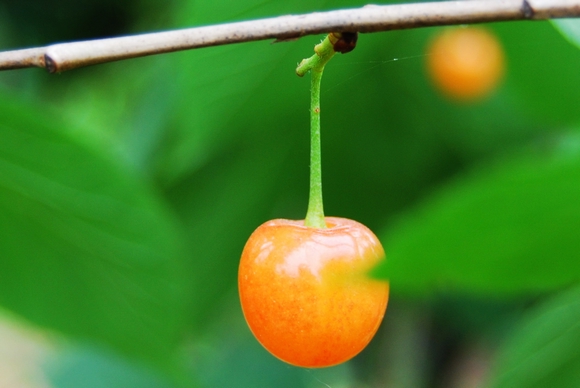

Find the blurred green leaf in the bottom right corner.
[{"left": 489, "top": 288, "right": 580, "bottom": 388}]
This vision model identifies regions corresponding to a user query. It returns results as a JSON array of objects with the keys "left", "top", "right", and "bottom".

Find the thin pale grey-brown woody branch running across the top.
[{"left": 0, "top": 0, "right": 580, "bottom": 73}]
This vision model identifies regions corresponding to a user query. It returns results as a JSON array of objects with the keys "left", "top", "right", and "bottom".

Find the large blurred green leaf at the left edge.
[{"left": 0, "top": 95, "right": 187, "bottom": 364}]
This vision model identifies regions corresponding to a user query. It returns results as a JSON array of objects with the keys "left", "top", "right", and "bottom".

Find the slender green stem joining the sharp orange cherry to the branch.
[{"left": 296, "top": 32, "right": 358, "bottom": 229}]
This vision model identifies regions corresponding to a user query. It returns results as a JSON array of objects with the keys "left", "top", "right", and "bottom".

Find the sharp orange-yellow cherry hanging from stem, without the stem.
[{"left": 238, "top": 217, "right": 389, "bottom": 368}]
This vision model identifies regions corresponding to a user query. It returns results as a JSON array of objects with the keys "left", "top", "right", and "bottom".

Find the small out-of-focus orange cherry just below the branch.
[{"left": 427, "top": 27, "right": 505, "bottom": 101}]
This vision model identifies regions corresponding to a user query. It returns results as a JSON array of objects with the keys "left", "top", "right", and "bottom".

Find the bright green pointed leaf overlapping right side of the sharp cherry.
[{"left": 377, "top": 136, "right": 580, "bottom": 294}]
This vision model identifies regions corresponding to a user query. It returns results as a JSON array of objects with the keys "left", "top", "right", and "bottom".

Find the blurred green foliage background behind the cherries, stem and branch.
[{"left": 0, "top": 0, "right": 580, "bottom": 388}]
